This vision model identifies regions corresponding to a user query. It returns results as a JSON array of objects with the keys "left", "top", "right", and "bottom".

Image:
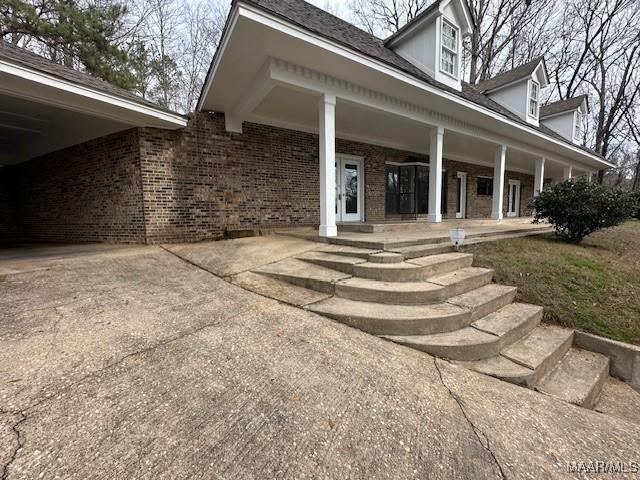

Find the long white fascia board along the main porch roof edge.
[{"left": 208, "top": 3, "right": 614, "bottom": 168}]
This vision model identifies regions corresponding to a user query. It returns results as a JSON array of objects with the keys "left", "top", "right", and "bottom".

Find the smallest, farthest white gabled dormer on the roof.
[{"left": 540, "top": 95, "right": 589, "bottom": 144}]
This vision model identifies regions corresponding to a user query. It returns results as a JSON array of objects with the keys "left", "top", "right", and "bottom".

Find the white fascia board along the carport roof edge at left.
[{"left": 0, "top": 60, "right": 187, "bottom": 128}]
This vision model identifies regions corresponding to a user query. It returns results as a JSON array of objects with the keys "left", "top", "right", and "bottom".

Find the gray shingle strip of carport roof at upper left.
[{"left": 0, "top": 39, "right": 181, "bottom": 113}]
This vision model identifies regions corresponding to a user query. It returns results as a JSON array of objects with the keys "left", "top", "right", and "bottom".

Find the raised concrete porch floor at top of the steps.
[{"left": 276, "top": 217, "right": 551, "bottom": 250}]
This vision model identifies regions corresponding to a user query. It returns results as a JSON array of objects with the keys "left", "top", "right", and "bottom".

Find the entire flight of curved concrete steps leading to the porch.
[{"left": 249, "top": 245, "right": 624, "bottom": 408}]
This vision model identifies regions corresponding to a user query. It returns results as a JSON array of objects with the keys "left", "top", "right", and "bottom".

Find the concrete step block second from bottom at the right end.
[{"left": 500, "top": 325, "right": 573, "bottom": 385}]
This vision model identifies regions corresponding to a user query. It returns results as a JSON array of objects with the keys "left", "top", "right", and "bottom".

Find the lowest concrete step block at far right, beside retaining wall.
[{"left": 536, "top": 348, "right": 609, "bottom": 409}]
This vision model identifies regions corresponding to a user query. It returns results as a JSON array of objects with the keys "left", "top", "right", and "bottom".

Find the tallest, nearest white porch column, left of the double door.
[{"left": 318, "top": 94, "right": 338, "bottom": 237}]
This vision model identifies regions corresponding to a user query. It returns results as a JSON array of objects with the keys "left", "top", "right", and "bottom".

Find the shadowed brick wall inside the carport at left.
[{"left": 0, "top": 129, "right": 145, "bottom": 243}]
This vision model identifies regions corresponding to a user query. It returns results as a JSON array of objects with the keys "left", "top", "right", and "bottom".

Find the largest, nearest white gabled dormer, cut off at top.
[{"left": 385, "top": 0, "right": 473, "bottom": 90}]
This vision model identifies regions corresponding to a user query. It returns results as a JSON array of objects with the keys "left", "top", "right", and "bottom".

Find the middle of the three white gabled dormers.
[{"left": 476, "top": 57, "right": 549, "bottom": 126}]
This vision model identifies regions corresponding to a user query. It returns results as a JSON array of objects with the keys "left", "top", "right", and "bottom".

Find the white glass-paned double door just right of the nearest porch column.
[{"left": 336, "top": 155, "right": 364, "bottom": 222}]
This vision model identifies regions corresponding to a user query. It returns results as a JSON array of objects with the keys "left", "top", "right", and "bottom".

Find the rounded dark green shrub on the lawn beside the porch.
[{"left": 531, "top": 180, "right": 637, "bottom": 243}]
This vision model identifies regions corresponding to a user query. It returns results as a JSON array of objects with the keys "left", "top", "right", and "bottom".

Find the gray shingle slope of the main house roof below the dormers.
[{"left": 241, "top": 0, "right": 602, "bottom": 158}]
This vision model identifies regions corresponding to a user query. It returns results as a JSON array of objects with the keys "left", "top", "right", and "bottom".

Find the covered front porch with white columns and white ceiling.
[{"left": 198, "top": 10, "right": 602, "bottom": 237}]
